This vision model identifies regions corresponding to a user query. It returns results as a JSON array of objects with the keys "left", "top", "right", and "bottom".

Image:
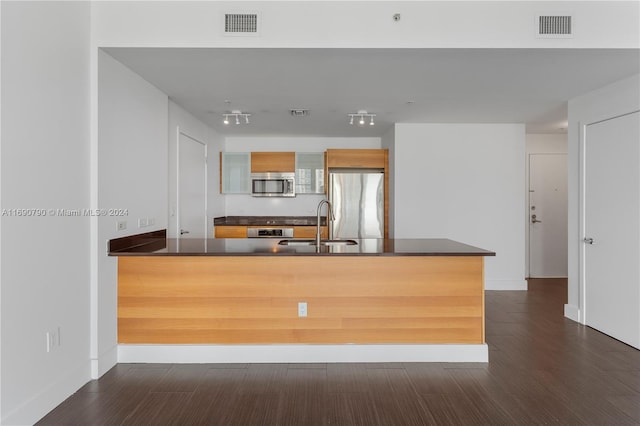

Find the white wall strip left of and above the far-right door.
[{"left": 564, "top": 74, "right": 640, "bottom": 321}]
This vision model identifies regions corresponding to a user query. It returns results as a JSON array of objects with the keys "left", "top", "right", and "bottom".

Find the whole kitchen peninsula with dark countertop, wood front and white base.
[{"left": 109, "top": 231, "right": 495, "bottom": 362}]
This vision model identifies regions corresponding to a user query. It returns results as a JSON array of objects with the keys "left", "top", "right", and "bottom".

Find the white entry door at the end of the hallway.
[{"left": 529, "top": 154, "right": 567, "bottom": 278}]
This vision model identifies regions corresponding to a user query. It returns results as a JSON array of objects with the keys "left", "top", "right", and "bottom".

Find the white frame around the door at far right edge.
[{"left": 577, "top": 110, "right": 640, "bottom": 325}]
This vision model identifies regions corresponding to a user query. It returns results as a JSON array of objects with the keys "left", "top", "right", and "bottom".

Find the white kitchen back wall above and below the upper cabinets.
[{"left": 225, "top": 137, "right": 381, "bottom": 216}]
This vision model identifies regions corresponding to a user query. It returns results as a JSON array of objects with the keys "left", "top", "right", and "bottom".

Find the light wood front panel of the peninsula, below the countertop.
[{"left": 118, "top": 256, "right": 484, "bottom": 344}]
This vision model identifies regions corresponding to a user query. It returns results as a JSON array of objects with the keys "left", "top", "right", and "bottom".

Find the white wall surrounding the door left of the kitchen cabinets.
[{"left": 167, "top": 101, "right": 225, "bottom": 238}]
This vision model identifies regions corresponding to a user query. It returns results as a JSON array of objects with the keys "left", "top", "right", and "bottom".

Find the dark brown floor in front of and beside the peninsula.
[{"left": 38, "top": 280, "right": 640, "bottom": 426}]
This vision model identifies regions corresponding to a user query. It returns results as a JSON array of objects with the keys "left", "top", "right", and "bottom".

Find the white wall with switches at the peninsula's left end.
[{"left": 91, "top": 51, "right": 169, "bottom": 377}]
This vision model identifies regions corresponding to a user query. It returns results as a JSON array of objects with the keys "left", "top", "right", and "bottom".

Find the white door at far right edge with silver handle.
[{"left": 583, "top": 112, "right": 640, "bottom": 348}]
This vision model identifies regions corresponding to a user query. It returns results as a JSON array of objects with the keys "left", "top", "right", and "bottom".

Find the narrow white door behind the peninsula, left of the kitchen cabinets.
[{"left": 177, "top": 133, "right": 207, "bottom": 238}]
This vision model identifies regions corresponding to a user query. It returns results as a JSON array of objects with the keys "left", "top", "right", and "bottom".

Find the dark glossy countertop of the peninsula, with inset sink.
[{"left": 109, "top": 231, "right": 495, "bottom": 256}]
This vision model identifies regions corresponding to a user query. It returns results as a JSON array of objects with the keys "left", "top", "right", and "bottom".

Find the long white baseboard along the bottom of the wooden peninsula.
[{"left": 118, "top": 344, "right": 489, "bottom": 363}]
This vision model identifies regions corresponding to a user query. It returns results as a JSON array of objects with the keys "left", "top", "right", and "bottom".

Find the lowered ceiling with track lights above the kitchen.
[{"left": 104, "top": 48, "right": 640, "bottom": 137}]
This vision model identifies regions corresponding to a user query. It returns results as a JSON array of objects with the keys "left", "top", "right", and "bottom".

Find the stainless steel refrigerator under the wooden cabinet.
[{"left": 329, "top": 169, "right": 384, "bottom": 238}]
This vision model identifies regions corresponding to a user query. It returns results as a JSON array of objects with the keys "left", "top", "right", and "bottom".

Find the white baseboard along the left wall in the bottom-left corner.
[{"left": 0, "top": 361, "right": 91, "bottom": 425}]
